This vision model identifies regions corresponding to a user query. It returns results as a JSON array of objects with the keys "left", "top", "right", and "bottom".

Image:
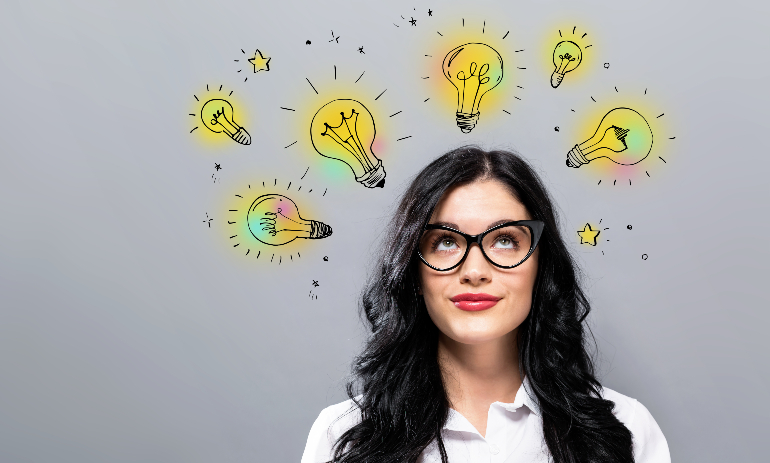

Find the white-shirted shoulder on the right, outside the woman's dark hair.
[{"left": 602, "top": 387, "right": 671, "bottom": 463}]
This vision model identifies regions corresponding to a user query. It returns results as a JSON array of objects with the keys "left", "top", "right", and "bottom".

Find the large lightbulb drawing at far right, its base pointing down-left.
[{"left": 567, "top": 108, "right": 652, "bottom": 167}]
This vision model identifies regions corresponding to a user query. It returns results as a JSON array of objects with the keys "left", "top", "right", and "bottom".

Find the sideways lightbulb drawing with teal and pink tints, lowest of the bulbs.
[{"left": 246, "top": 194, "right": 332, "bottom": 246}]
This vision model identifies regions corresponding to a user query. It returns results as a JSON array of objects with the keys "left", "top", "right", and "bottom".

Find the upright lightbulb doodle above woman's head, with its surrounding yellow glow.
[{"left": 421, "top": 18, "right": 527, "bottom": 133}]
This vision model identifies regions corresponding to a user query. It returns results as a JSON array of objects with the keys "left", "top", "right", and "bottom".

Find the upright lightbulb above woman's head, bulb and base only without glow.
[{"left": 442, "top": 43, "right": 503, "bottom": 133}]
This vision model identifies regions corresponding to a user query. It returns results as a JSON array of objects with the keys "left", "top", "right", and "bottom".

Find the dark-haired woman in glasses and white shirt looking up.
[{"left": 302, "top": 147, "right": 670, "bottom": 463}]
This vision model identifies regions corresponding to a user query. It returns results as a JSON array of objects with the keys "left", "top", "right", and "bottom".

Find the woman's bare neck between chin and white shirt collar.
[{"left": 438, "top": 330, "right": 522, "bottom": 413}]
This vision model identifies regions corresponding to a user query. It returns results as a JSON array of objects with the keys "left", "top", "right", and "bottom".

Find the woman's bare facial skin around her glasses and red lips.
[{"left": 420, "top": 180, "right": 538, "bottom": 344}]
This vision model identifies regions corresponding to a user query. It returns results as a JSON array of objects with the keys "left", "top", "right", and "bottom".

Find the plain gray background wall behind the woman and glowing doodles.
[{"left": 0, "top": 0, "right": 770, "bottom": 463}]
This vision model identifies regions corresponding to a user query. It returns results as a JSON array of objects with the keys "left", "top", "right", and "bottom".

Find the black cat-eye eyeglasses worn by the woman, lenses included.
[{"left": 417, "top": 220, "right": 545, "bottom": 272}]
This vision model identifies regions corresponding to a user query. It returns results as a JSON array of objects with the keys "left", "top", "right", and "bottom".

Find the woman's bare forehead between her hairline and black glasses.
[{"left": 430, "top": 180, "right": 531, "bottom": 233}]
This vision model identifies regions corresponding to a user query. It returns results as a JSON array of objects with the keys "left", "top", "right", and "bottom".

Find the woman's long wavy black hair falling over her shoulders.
[{"left": 333, "top": 146, "right": 634, "bottom": 463}]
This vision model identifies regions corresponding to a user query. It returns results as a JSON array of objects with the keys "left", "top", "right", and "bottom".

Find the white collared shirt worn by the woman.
[{"left": 301, "top": 378, "right": 671, "bottom": 463}]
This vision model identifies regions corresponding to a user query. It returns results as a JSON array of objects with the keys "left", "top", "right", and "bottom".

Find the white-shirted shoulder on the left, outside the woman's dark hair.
[{"left": 302, "top": 399, "right": 361, "bottom": 463}]
